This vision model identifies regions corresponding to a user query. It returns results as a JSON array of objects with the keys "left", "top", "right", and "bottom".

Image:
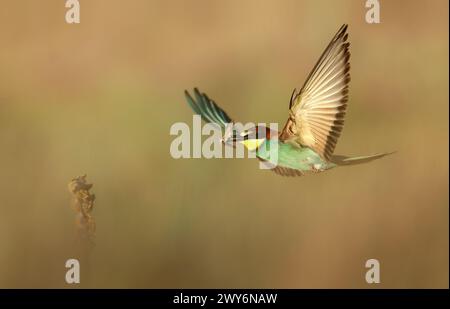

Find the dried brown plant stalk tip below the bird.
[{"left": 69, "top": 175, "right": 95, "bottom": 244}]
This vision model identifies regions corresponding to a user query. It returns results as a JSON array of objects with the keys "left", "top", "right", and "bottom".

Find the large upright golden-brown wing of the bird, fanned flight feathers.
[{"left": 279, "top": 25, "right": 350, "bottom": 160}]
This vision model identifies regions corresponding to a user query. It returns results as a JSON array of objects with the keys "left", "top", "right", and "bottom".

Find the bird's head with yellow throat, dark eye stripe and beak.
[{"left": 223, "top": 126, "right": 274, "bottom": 151}]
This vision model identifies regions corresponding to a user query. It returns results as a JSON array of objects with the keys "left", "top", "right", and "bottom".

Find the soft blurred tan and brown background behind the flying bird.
[{"left": 0, "top": 0, "right": 449, "bottom": 288}]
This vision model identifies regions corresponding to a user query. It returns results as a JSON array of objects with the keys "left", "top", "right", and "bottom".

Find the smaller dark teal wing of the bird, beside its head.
[{"left": 184, "top": 88, "right": 233, "bottom": 128}]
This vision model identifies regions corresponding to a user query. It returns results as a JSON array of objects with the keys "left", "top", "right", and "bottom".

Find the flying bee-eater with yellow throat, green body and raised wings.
[{"left": 185, "top": 24, "right": 390, "bottom": 176}]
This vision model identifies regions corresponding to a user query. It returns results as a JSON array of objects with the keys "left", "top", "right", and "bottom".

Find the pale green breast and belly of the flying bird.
[{"left": 256, "top": 140, "right": 335, "bottom": 171}]
